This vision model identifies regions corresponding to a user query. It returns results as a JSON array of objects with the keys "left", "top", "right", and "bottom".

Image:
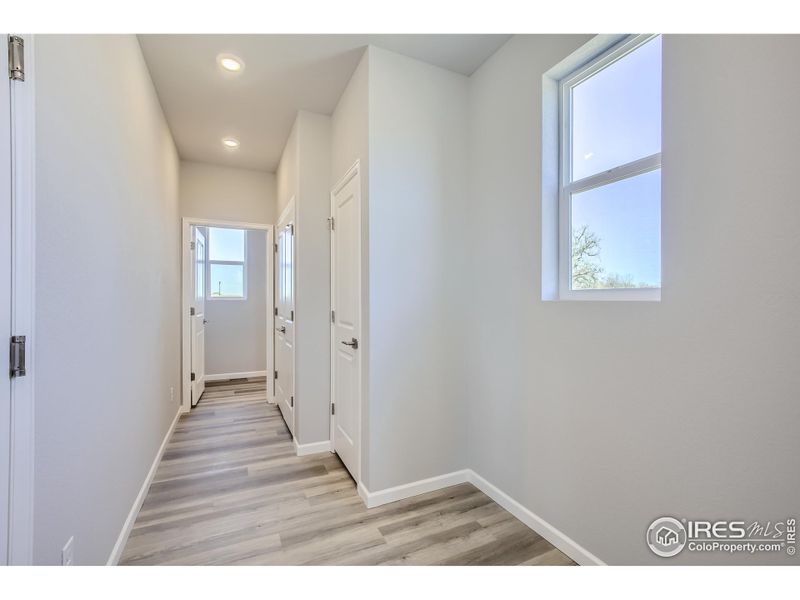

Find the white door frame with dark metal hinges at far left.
[{"left": 1, "top": 34, "right": 36, "bottom": 565}]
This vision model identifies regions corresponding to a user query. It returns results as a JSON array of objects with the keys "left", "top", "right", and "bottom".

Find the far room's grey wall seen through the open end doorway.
[{"left": 205, "top": 229, "right": 267, "bottom": 375}]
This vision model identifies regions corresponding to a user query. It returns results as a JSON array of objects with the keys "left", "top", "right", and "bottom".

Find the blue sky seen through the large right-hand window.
[{"left": 570, "top": 36, "right": 661, "bottom": 289}]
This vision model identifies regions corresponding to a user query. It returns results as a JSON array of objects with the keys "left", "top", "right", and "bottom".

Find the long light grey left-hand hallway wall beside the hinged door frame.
[{"left": 34, "top": 35, "right": 180, "bottom": 564}]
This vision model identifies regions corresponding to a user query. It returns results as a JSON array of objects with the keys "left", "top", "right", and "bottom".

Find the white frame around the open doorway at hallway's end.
[{"left": 180, "top": 217, "right": 275, "bottom": 413}]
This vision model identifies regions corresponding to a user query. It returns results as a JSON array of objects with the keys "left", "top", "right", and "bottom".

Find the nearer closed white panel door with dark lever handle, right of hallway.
[{"left": 331, "top": 168, "right": 362, "bottom": 481}]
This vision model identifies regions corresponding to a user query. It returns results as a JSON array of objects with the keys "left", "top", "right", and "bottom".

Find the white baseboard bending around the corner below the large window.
[{"left": 358, "top": 469, "right": 605, "bottom": 565}]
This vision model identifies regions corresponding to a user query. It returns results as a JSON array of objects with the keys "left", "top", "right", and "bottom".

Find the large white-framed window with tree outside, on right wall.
[{"left": 558, "top": 36, "right": 661, "bottom": 300}]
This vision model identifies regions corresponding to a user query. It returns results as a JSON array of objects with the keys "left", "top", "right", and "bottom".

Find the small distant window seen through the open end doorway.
[{"left": 206, "top": 227, "right": 247, "bottom": 300}]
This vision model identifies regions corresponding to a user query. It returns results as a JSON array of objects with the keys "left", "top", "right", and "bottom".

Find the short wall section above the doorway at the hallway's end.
[{"left": 180, "top": 160, "right": 278, "bottom": 224}]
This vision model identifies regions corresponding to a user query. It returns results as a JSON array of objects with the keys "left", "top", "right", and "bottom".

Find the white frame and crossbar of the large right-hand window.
[{"left": 558, "top": 34, "right": 661, "bottom": 301}]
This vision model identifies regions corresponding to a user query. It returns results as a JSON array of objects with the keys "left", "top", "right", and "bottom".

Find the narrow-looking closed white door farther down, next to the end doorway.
[{"left": 275, "top": 202, "right": 294, "bottom": 435}]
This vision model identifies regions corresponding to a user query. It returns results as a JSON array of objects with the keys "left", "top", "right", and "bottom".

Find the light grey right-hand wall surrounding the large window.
[{"left": 460, "top": 36, "right": 800, "bottom": 564}]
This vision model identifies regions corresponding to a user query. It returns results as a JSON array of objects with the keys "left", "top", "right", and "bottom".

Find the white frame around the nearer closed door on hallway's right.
[{"left": 329, "top": 159, "right": 367, "bottom": 486}]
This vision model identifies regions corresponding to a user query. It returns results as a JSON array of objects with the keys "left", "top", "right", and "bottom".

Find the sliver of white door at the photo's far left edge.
[{"left": 0, "top": 35, "right": 11, "bottom": 565}]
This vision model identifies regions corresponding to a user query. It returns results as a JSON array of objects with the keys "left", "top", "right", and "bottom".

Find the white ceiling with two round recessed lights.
[{"left": 139, "top": 35, "right": 510, "bottom": 171}]
